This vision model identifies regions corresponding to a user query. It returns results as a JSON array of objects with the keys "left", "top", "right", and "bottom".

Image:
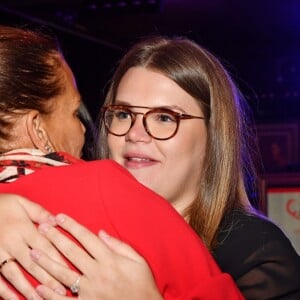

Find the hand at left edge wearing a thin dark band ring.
[{"left": 0, "top": 194, "right": 64, "bottom": 299}]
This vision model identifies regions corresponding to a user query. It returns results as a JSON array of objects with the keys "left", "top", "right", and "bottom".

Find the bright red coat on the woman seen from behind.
[{"left": 0, "top": 160, "right": 243, "bottom": 300}]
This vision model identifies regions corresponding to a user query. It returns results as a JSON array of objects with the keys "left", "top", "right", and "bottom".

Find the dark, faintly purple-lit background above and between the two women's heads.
[{"left": 0, "top": 0, "right": 300, "bottom": 171}]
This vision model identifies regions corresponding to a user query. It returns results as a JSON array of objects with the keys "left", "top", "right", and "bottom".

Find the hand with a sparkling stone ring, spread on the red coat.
[{"left": 31, "top": 215, "right": 162, "bottom": 300}]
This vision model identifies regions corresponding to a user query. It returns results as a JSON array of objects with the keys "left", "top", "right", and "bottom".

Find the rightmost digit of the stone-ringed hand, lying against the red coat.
[{"left": 99, "top": 230, "right": 145, "bottom": 262}]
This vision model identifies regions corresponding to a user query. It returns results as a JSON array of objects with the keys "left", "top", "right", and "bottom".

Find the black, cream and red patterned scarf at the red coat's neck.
[{"left": 0, "top": 149, "right": 82, "bottom": 183}]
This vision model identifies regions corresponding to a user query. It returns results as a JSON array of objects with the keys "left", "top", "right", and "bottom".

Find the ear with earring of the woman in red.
[{"left": 26, "top": 110, "right": 52, "bottom": 153}]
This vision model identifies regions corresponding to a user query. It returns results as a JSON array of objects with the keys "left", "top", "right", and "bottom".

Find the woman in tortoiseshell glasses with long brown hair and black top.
[{"left": 1, "top": 33, "right": 300, "bottom": 299}]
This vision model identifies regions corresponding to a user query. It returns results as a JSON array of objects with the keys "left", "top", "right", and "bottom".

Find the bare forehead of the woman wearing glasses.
[{"left": 115, "top": 67, "right": 200, "bottom": 112}]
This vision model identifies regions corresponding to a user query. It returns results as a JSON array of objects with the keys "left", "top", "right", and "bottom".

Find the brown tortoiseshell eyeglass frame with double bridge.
[{"left": 101, "top": 104, "right": 206, "bottom": 141}]
